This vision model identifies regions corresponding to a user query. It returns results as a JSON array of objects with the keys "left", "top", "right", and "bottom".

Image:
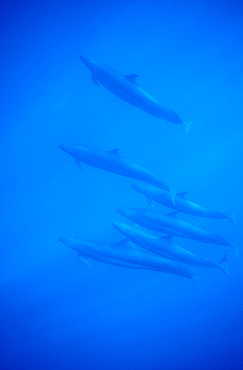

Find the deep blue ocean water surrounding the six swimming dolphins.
[{"left": 0, "top": 0, "right": 243, "bottom": 370}]
